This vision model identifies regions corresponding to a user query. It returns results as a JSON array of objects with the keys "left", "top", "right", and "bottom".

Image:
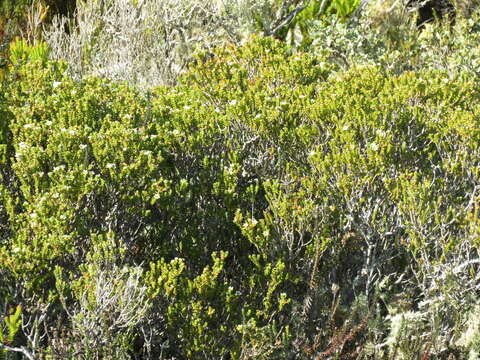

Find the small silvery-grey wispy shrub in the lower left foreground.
[{"left": 65, "top": 267, "right": 150, "bottom": 359}]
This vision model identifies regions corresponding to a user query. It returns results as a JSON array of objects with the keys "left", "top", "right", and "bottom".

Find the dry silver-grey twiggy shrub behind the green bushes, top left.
[{"left": 44, "top": 0, "right": 272, "bottom": 88}]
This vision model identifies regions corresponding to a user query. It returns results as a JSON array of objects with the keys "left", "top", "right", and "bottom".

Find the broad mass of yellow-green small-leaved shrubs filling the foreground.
[{"left": 0, "top": 32, "right": 480, "bottom": 359}]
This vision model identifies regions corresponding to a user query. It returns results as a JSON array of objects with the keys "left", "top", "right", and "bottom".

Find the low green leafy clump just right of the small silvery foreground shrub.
[{"left": 146, "top": 252, "right": 235, "bottom": 358}]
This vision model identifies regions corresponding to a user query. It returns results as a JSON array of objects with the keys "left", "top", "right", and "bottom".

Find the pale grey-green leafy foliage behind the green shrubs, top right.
[{"left": 309, "top": 2, "right": 480, "bottom": 76}]
